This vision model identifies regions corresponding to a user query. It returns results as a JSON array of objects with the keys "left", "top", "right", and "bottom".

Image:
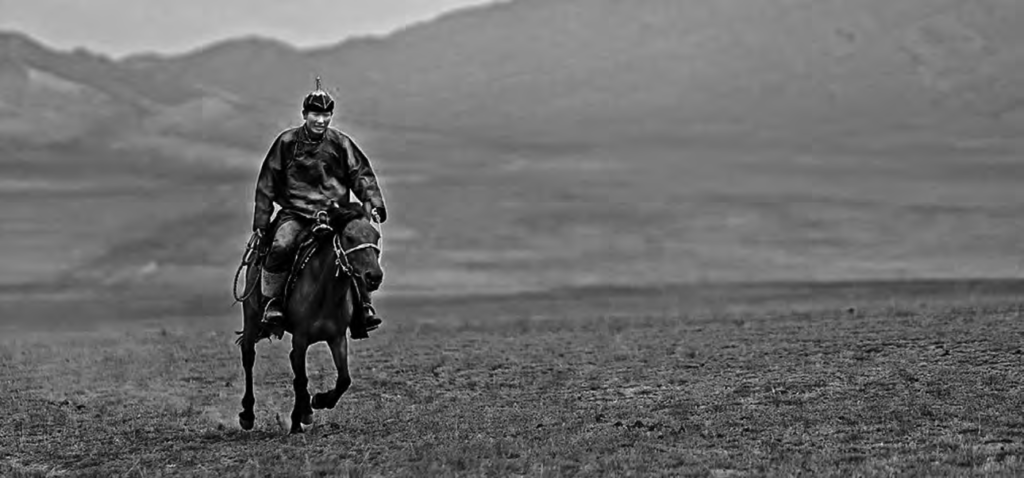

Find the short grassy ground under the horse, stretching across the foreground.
[{"left": 0, "top": 285, "right": 1024, "bottom": 476}]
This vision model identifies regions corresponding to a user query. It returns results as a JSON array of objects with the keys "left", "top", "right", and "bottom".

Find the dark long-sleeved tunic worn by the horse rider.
[{"left": 253, "top": 126, "right": 386, "bottom": 230}]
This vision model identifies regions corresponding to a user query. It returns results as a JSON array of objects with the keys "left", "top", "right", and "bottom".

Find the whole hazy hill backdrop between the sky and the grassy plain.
[{"left": 0, "top": 0, "right": 1024, "bottom": 313}]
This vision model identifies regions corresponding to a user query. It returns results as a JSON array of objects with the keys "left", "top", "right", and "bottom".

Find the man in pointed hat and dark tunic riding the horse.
[{"left": 253, "top": 77, "right": 387, "bottom": 332}]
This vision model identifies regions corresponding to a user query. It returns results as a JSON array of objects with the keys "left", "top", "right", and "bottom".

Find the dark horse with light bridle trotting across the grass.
[{"left": 238, "top": 204, "right": 384, "bottom": 433}]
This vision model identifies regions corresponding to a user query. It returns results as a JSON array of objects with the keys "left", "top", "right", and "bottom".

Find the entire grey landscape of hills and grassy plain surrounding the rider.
[{"left": 0, "top": 0, "right": 1024, "bottom": 476}]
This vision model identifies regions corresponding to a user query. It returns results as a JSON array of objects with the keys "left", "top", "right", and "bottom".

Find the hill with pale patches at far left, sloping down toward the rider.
[{"left": 0, "top": 33, "right": 276, "bottom": 147}]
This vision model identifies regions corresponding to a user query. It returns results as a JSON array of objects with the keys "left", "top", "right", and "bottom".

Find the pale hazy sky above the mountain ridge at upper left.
[{"left": 0, "top": 0, "right": 490, "bottom": 56}]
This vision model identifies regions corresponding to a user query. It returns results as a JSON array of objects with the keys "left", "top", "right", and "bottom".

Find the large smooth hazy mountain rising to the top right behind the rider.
[{"left": 132, "top": 0, "right": 1024, "bottom": 144}]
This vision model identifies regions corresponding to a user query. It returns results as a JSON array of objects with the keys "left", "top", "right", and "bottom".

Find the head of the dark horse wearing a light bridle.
[{"left": 327, "top": 203, "right": 384, "bottom": 292}]
